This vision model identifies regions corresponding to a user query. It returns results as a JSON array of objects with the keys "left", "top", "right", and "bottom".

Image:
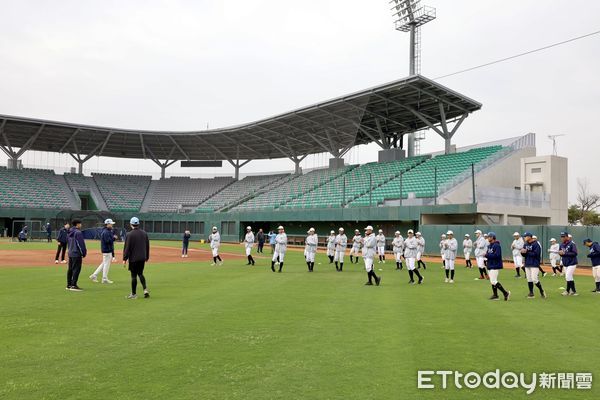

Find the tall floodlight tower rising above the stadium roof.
[{"left": 389, "top": 0, "right": 435, "bottom": 76}]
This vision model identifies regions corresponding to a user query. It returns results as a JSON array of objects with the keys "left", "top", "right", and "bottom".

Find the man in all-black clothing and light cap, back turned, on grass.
[{"left": 123, "top": 217, "right": 150, "bottom": 300}]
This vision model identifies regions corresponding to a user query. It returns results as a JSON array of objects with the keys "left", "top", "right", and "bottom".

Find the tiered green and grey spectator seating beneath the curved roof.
[{"left": 0, "top": 146, "right": 507, "bottom": 212}]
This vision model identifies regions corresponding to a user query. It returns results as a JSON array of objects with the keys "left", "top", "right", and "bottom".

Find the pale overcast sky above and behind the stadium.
[{"left": 0, "top": 0, "right": 600, "bottom": 200}]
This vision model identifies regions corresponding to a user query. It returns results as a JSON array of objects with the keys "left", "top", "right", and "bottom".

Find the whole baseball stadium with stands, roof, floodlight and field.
[{"left": 0, "top": 0, "right": 600, "bottom": 399}]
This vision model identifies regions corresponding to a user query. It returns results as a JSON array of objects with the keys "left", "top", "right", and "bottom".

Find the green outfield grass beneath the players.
[{"left": 0, "top": 242, "right": 600, "bottom": 399}]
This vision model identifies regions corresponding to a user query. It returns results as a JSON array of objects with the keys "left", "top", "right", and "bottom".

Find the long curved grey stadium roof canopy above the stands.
[{"left": 0, "top": 75, "right": 481, "bottom": 165}]
